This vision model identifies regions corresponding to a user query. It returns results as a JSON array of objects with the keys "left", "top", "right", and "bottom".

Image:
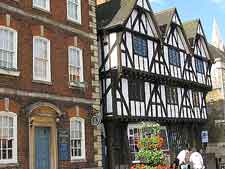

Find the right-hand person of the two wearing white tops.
[{"left": 190, "top": 150, "right": 205, "bottom": 169}]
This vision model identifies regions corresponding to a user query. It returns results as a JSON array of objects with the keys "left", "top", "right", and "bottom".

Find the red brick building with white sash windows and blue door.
[{"left": 0, "top": 0, "right": 102, "bottom": 169}]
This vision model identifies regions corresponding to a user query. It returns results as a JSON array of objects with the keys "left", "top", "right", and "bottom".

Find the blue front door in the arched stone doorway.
[{"left": 35, "top": 127, "right": 50, "bottom": 169}]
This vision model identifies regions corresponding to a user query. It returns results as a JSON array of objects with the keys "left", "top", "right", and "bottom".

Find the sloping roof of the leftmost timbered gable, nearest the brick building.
[{"left": 97, "top": 0, "right": 137, "bottom": 29}]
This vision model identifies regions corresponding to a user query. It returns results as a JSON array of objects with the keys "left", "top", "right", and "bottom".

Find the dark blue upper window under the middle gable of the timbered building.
[{"left": 168, "top": 47, "right": 181, "bottom": 67}]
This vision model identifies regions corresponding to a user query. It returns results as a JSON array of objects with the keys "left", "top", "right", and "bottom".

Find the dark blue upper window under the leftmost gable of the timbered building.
[{"left": 133, "top": 35, "right": 148, "bottom": 57}]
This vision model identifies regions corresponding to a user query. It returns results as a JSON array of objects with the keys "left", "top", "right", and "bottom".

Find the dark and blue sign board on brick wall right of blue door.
[{"left": 58, "top": 128, "right": 70, "bottom": 161}]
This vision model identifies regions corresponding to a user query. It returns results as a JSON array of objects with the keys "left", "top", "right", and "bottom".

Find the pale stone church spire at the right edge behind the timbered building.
[{"left": 212, "top": 18, "right": 224, "bottom": 51}]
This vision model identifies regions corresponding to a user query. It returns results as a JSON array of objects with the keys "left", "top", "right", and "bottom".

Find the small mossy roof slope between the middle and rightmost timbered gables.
[{"left": 183, "top": 19, "right": 200, "bottom": 39}]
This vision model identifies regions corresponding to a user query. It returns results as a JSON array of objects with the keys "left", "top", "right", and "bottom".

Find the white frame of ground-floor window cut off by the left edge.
[{"left": 0, "top": 111, "right": 17, "bottom": 164}]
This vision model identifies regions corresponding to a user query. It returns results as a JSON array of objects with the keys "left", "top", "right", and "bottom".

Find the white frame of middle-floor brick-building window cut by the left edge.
[{"left": 0, "top": 26, "right": 18, "bottom": 70}]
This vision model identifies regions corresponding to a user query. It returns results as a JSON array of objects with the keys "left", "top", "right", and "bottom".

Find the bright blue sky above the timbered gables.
[{"left": 150, "top": 0, "right": 225, "bottom": 42}]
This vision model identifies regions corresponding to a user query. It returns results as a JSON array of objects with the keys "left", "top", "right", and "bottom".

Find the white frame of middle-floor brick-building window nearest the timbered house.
[{"left": 68, "top": 46, "right": 84, "bottom": 85}]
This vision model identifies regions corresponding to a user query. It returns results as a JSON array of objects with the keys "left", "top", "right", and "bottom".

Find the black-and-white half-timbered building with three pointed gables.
[{"left": 97, "top": 0, "right": 212, "bottom": 169}]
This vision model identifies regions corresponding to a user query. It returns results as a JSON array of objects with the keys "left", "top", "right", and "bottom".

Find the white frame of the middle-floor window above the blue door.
[{"left": 33, "top": 36, "right": 51, "bottom": 83}]
